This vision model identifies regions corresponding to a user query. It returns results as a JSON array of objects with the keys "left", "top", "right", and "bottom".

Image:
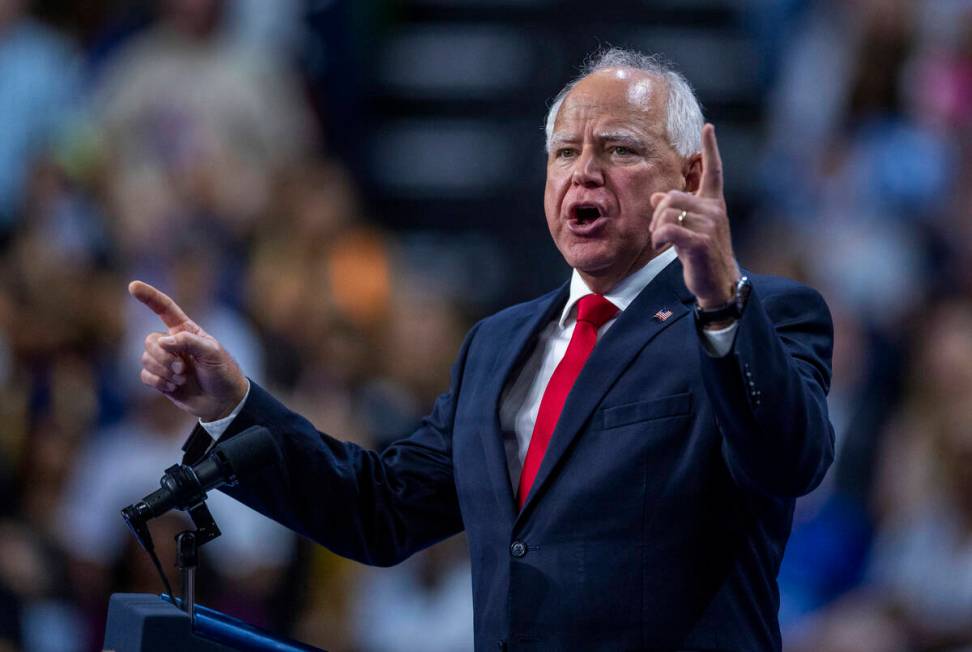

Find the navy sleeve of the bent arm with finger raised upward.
[{"left": 700, "top": 283, "right": 834, "bottom": 496}]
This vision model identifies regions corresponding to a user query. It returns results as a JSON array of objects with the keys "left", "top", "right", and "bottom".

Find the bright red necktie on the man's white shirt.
[{"left": 516, "top": 294, "right": 618, "bottom": 509}]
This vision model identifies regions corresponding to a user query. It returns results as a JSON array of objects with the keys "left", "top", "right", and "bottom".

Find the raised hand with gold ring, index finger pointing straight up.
[{"left": 649, "top": 124, "right": 739, "bottom": 308}]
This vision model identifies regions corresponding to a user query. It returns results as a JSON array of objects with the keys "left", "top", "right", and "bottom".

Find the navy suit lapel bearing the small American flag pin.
[{"left": 520, "top": 260, "right": 694, "bottom": 522}]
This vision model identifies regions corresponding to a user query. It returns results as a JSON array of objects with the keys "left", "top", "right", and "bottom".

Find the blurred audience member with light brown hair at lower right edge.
[{"left": 794, "top": 302, "right": 972, "bottom": 652}]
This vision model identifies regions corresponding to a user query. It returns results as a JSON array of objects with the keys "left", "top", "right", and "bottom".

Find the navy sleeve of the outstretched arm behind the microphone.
[{"left": 200, "top": 329, "right": 475, "bottom": 566}]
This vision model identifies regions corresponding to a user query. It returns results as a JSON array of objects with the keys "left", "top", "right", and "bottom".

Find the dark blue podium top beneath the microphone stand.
[{"left": 104, "top": 593, "right": 323, "bottom": 652}]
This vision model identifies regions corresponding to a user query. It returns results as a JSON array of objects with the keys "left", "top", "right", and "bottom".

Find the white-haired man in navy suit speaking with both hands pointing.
[{"left": 130, "top": 50, "right": 833, "bottom": 652}]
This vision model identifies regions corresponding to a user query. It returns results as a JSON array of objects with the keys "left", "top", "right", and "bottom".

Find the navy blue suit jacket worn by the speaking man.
[{"left": 199, "top": 261, "right": 834, "bottom": 652}]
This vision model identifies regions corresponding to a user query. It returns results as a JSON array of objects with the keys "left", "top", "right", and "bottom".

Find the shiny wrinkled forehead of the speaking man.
[{"left": 554, "top": 68, "right": 668, "bottom": 130}]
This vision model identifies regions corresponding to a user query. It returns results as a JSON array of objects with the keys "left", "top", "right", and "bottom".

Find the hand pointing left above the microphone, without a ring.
[{"left": 128, "top": 281, "right": 248, "bottom": 421}]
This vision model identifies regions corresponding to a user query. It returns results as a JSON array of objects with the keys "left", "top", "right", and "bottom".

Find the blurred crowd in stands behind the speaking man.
[{"left": 0, "top": 0, "right": 972, "bottom": 652}]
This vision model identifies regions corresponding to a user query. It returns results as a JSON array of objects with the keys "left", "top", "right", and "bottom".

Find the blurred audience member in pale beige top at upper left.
[{"left": 92, "top": 0, "right": 313, "bottom": 259}]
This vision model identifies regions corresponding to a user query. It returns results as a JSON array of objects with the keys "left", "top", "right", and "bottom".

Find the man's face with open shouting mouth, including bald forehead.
[{"left": 543, "top": 68, "right": 698, "bottom": 292}]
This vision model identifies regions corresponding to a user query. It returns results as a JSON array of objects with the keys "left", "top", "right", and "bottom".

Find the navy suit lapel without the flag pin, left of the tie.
[{"left": 483, "top": 283, "right": 570, "bottom": 521}]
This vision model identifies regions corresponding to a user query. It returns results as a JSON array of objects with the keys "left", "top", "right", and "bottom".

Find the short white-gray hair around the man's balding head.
[{"left": 544, "top": 48, "right": 705, "bottom": 156}]
